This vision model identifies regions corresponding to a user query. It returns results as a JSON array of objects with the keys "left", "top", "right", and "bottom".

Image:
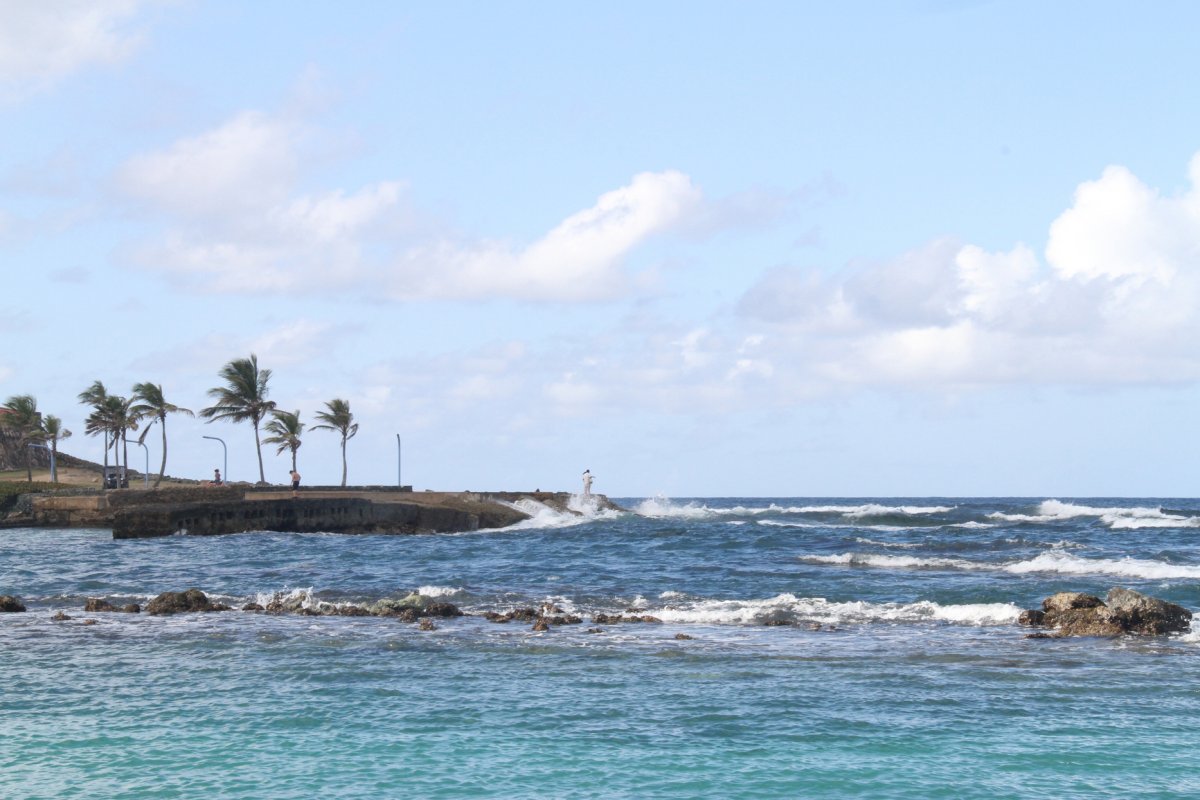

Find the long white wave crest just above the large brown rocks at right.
[{"left": 799, "top": 549, "right": 1200, "bottom": 581}]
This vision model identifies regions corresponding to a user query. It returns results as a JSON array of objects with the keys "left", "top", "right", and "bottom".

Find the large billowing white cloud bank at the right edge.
[{"left": 725, "top": 155, "right": 1200, "bottom": 390}]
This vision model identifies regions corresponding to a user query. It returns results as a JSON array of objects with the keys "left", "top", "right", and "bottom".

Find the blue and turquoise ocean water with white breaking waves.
[{"left": 0, "top": 498, "right": 1200, "bottom": 800}]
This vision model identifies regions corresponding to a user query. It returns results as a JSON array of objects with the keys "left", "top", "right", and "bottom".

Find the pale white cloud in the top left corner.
[{"left": 0, "top": 0, "right": 144, "bottom": 95}]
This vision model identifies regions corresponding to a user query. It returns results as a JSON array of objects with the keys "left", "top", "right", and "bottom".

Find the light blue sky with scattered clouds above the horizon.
[{"left": 0, "top": 0, "right": 1200, "bottom": 497}]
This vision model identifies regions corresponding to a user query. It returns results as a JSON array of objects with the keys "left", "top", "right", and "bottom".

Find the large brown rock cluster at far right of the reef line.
[{"left": 1018, "top": 588, "right": 1192, "bottom": 638}]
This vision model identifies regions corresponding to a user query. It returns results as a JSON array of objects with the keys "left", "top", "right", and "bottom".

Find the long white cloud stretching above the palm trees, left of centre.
[{"left": 115, "top": 112, "right": 724, "bottom": 302}]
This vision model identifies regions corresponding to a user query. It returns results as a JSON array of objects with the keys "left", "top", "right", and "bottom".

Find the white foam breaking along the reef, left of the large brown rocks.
[{"left": 649, "top": 594, "right": 1021, "bottom": 626}]
